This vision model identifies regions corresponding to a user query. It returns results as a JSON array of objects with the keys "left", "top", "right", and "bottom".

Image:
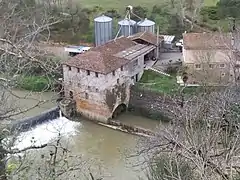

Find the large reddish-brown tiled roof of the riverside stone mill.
[{"left": 63, "top": 37, "right": 136, "bottom": 74}]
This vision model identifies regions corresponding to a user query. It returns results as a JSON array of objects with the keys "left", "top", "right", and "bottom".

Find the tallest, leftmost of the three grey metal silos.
[{"left": 94, "top": 15, "right": 113, "bottom": 46}]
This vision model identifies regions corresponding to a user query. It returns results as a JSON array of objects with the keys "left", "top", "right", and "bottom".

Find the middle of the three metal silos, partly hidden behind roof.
[{"left": 118, "top": 19, "right": 136, "bottom": 37}]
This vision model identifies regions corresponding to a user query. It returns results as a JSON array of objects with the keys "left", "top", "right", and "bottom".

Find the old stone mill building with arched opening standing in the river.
[{"left": 63, "top": 34, "right": 162, "bottom": 122}]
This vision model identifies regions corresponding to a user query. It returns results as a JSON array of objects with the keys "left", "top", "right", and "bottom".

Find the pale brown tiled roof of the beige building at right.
[{"left": 183, "top": 33, "right": 232, "bottom": 50}]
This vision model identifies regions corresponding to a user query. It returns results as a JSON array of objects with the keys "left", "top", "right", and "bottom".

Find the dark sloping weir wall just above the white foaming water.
[{"left": 10, "top": 107, "right": 60, "bottom": 132}]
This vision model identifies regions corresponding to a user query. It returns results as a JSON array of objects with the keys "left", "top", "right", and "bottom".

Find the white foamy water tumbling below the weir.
[{"left": 7, "top": 116, "right": 81, "bottom": 150}]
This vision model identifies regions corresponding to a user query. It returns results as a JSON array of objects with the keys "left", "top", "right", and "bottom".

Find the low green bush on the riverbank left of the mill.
[{"left": 18, "top": 76, "right": 51, "bottom": 92}]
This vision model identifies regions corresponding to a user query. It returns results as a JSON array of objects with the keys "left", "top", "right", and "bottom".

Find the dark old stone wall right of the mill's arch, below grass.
[{"left": 128, "top": 86, "right": 177, "bottom": 122}]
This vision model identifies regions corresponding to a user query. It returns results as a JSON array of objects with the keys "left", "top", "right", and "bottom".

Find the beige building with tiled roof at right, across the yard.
[{"left": 183, "top": 33, "right": 237, "bottom": 85}]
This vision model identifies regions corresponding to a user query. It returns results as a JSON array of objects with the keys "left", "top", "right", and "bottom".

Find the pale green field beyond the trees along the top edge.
[{"left": 79, "top": 0, "right": 218, "bottom": 11}]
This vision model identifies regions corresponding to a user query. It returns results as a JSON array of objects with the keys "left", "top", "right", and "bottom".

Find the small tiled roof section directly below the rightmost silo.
[{"left": 130, "top": 31, "right": 163, "bottom": 45}]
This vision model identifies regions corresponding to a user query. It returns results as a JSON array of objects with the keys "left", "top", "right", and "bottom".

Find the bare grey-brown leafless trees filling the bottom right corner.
[{"left": 138, "top": 87, "right": 240, "bottom": 180}]
